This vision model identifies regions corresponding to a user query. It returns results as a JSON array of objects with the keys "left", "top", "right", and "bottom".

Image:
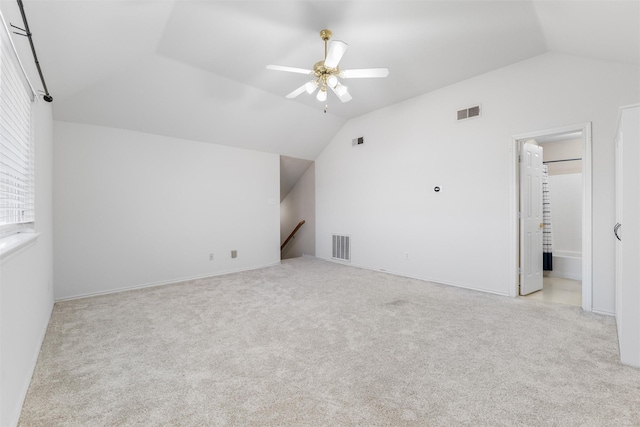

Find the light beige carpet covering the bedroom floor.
[{"left": 20, "top": 258, "right": 640, "bottom": 426}]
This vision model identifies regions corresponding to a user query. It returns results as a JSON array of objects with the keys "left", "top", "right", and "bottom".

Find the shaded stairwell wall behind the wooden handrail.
[{"left": 280, "top": 163, "right": 316, "bottom": 259}]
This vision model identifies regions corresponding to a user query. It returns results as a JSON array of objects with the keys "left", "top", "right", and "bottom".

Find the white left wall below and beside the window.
[{"left": 0, "top": 101, "right": 53, "bottom": 426}]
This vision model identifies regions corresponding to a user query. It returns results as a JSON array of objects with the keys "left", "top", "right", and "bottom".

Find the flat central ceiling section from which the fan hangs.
[{"left": 152, "top": 1, "right": 546, "bottom": 118}]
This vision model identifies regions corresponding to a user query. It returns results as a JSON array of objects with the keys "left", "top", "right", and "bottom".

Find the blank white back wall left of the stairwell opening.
[{"left": 54, "top": 121, "right": 280, "bottom": 299}]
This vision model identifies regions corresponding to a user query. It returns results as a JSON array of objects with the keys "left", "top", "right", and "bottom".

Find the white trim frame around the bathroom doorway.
[{"left": 509, "top": 122, "right": 593, "bottom": 311}]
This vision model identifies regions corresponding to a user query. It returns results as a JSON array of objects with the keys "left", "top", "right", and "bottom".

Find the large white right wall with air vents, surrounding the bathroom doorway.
[{"left": 316, "top": 54, "right": 640, "bottom": 313}]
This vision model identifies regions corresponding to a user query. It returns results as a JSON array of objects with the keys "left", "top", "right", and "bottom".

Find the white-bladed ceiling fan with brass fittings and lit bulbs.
[{"left": 267, "top": 30, "right": 389, "bottom": 113}]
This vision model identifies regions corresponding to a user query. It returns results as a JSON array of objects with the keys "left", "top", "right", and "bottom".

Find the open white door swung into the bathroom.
[{"left": 520, "top": 142, "right": 544, "bottom": 295}]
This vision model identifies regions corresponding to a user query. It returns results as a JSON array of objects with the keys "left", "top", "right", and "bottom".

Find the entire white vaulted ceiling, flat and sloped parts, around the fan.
[{"left": 0, "top": 0, "right": 640, "bottom": 159}]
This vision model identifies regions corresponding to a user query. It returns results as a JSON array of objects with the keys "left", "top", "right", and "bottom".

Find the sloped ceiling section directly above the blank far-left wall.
[{"left": 55, "top": 54, "right": 344, "bottom": 158}]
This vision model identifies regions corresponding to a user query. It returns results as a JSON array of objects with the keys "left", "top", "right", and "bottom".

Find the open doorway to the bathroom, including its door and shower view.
[{"left": 510, "top": 123, "right": 592, "bottom": 311}]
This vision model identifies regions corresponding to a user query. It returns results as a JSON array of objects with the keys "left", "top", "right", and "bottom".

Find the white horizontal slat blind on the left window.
[{"left": 0, "top": 10, "right": 35, "bottom": 236}]
